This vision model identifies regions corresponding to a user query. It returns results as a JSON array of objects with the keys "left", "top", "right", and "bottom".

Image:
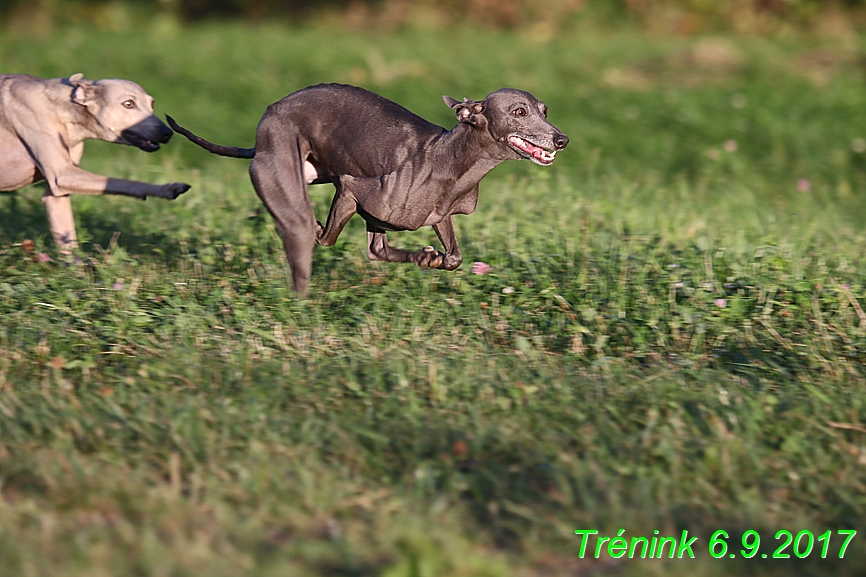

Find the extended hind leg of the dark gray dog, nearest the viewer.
[{"left": 250, "top": 134, "right": 317, "bottom": 297}]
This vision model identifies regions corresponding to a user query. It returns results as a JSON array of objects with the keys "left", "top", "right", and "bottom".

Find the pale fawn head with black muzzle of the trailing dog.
[{"left": 69, "top": 74, "right": 172, "bottom": 152}]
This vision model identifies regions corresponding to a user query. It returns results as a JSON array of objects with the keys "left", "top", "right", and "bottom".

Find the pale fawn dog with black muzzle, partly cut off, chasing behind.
[{"left": 0, "top": 74, "right": 189, "bottom": 249}]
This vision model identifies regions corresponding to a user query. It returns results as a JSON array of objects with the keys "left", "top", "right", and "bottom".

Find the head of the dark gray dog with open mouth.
[{"left": 442, "top": 88, "right": 568, "bottom": 166}]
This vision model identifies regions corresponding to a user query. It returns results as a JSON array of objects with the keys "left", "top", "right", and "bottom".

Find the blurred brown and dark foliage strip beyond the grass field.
[{"left": 0, "top": 0, "right": 866, "bottom": 34}]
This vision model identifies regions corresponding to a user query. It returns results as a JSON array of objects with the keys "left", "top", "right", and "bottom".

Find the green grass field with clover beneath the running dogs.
[{"left": 0, "top": 20, "right": 866, "bottom": 577}]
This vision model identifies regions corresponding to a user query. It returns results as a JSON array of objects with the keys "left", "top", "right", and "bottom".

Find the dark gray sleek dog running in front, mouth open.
[{"left": 168, "top": 84, "right": 568, "bottom": 295}]
